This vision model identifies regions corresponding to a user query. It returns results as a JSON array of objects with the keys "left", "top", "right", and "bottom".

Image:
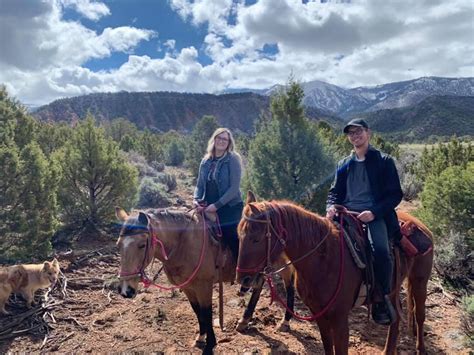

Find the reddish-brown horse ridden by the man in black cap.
[{"left": 237, "top": 193, "right": 433, "bottom": 354}]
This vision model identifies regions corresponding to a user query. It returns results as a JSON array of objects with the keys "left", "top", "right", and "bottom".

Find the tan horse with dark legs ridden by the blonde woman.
[{"left": 115, "top": 208, "right": 290, "bottom": 353}]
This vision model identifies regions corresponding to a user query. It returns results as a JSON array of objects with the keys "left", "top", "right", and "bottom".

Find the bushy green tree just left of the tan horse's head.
[{"left": 56, "top": 115, "right": 138, "bottom": 234}]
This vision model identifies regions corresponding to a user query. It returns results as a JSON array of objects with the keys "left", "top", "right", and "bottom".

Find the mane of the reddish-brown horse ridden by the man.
[{"left": 253, "top": 200, "right": 339, "bottom": 250}]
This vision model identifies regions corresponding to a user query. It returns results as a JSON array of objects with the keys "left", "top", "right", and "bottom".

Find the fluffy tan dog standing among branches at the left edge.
[{"left": 0, "top": 259, "right": 59, "bottom": 313}]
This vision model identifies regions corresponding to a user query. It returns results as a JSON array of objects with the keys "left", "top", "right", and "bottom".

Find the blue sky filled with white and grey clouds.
[{"left": 0, "top": 0, "right": 474, "bottom": 106}]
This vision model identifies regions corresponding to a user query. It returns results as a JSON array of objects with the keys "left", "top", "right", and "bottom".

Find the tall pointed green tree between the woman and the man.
[{"left": 247, "top": 81, "right": 333, "bottom": 210}]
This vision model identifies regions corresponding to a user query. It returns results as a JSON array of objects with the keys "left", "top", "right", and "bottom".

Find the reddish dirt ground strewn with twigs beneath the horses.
[{"left": 0, "top": 168, "right": 469, "bottom": 354}]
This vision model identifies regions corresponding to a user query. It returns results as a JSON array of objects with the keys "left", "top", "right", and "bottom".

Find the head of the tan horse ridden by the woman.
[{"left": 115, "top": 207, "right": 154, "bottom": 298}]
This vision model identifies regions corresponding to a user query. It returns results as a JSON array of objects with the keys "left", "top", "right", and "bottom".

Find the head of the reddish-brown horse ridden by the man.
[{"left": 237, "top": 191, "right": 285, "bottom": 287}]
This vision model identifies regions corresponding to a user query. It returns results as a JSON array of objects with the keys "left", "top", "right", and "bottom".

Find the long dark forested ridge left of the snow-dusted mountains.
[{"left": 35, "top": 92, "right": 270, "bottom": 132}]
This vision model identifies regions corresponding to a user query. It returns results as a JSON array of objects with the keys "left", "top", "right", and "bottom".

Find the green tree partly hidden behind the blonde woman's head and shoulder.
[{"left": 186, "top": 116, "right": 219, "bottom": 177}]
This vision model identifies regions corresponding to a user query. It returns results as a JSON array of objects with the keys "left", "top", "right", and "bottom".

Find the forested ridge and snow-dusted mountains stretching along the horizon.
[{"left": 34, "top": 77, "right": 474, "bottom": 140}]
